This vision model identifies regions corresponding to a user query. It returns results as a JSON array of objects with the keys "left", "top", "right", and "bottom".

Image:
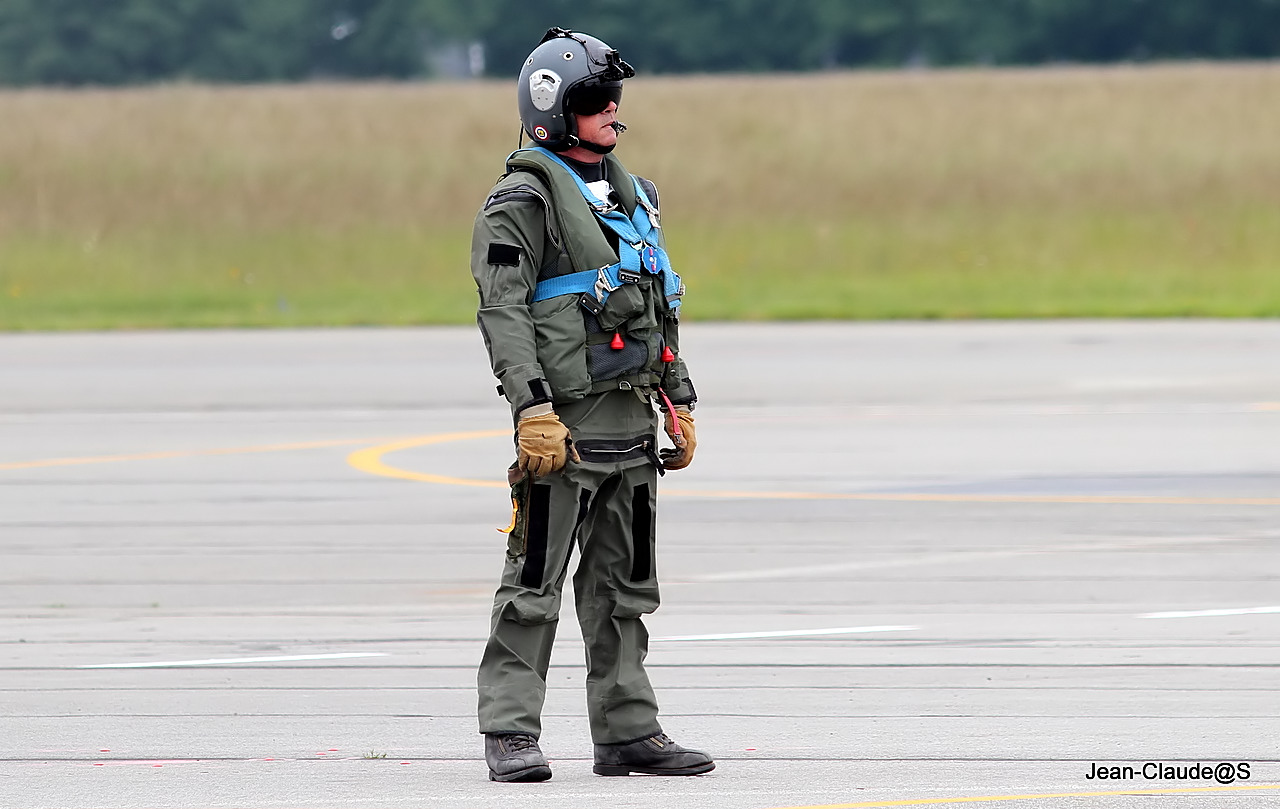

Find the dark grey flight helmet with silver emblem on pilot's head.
[{"left": 516, "top": 28, "right": 636, "bottom": 151}]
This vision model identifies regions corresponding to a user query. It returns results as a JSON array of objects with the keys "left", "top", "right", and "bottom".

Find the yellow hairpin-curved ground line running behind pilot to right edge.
[{"left": 347, "top": 430, "right": 1280, "bottom": 506}]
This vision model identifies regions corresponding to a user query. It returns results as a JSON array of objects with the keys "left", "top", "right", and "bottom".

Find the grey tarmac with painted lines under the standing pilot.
[{"left": 0, "top": 320, "right": 1280, "bottom": 809}]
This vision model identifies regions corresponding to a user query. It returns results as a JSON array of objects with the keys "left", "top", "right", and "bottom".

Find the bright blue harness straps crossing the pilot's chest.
[{"left": 527, "top": 146, "right": 684, "bottom": 310}]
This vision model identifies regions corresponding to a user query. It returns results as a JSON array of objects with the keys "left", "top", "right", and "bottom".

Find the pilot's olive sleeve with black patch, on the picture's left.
[{"left": 471, "top": 178, "right": 552, "bottom": 417}]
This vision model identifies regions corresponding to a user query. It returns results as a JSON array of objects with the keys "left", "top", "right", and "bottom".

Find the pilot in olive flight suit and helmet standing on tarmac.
[{"left": 471, "top": 28, "right": 716, "bottom": 781}]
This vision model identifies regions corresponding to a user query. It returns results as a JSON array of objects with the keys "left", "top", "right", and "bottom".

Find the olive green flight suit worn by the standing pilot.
[{"left": 471, "top": 152, "right": 696, "bottom": 744}]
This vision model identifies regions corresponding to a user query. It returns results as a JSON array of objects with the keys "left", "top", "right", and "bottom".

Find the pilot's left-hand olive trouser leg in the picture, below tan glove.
[{"left": 476, "top": 474, "right": 581, "bottom": 737}]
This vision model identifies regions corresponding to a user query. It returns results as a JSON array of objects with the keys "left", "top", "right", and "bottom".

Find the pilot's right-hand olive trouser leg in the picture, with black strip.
[{"left": 573, "top": 465, "right": 662, "bottom": 744}]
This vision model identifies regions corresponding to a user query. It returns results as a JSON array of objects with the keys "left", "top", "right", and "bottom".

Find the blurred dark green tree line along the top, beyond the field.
[{"left": 0, "top": 0, "right": 1280, "bottom": 86}]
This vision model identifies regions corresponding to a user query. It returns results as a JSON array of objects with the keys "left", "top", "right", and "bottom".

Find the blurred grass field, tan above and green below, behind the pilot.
[{"left": 0, "top": 65, "right": 1280, "bottom": 329}]
